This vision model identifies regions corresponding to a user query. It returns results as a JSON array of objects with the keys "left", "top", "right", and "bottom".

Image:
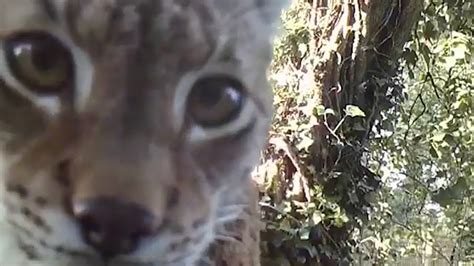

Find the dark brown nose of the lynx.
[{"left": 72, "top": 198, "right": 156, "bottom": 259}]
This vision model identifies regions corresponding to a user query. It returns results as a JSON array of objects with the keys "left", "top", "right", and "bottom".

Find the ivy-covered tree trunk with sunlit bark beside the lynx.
[{"left": 256, "top": 0, "right": 423, "bottom": 266}]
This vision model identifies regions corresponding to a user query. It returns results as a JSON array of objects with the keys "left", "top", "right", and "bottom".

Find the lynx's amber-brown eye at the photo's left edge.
[{"left": 4, "top": 32, "right": 73, "bottom": 94}]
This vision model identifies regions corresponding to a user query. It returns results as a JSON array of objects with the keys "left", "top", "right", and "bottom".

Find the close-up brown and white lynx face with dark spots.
[{"left": 0, "top": 0, "right": 282, "bottom": 266}]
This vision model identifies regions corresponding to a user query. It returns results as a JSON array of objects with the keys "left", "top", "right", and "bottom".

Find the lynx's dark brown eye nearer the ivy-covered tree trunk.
[{"left": 187, "top": 76, "right": 246, "bottom": 127}]
